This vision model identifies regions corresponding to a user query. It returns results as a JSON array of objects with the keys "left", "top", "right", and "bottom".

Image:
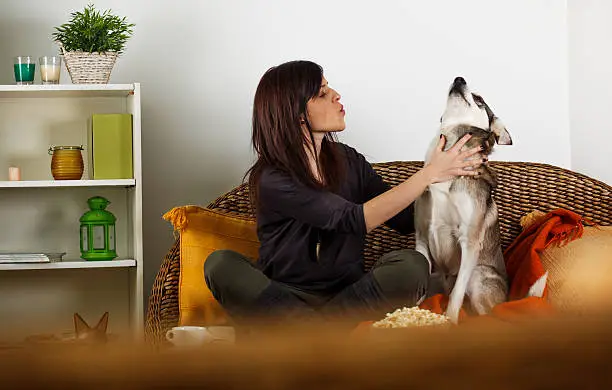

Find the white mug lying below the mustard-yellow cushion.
[{"left": 166, "top": 326, "right": 236, "bottom": 347}]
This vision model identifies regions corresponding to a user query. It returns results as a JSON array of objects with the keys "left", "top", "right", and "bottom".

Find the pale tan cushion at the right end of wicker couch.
[{"left": 521, "top": 211, "right": 612, "bottom": 312}]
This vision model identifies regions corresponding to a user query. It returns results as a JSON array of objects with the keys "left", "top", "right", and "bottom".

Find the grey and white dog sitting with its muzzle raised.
[{"left": 415, "top": 77, "right": 512, "bottom": 323}]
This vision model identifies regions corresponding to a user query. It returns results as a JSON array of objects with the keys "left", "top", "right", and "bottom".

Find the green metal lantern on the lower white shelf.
[{"left": 79, "top": 196, "right": 117, "bottom": 260}]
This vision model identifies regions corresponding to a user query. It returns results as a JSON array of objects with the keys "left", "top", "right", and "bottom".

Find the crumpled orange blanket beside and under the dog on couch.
[{"left": 420, "top": 209, "right": 590, "bottom": 322}]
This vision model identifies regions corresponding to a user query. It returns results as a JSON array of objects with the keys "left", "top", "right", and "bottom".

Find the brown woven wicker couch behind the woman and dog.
[{"left": 145, "top": 161, "right": 612, "bottom": 343}]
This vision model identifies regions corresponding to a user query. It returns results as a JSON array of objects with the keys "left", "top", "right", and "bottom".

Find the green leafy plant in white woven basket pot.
[{"left": 52, "top": 4, "right": 135, "bottom": 84}]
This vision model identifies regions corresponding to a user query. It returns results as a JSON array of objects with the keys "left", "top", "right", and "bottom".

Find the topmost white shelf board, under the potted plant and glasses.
[{"left": 0, "top": 84, "right": 134, "bottom": 98}]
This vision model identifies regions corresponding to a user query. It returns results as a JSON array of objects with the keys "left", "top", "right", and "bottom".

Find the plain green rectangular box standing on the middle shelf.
[{"left": 90, "top": 114, "right": 134, "bottom": 180}]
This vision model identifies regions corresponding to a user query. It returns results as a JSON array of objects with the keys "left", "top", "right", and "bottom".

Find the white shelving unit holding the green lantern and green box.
[{"left": 0, "top": 83, "right": 144, "bottom": 342}]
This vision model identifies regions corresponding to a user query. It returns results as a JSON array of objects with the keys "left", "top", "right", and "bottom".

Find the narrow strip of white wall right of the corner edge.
[{"left": 568, "top": 0, "right": 612, "bottom": 183}]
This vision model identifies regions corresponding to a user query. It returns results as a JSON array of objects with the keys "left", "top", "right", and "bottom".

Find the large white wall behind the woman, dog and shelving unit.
[{"left": 0, "top": 0, "right": 571, "bottom": 310}]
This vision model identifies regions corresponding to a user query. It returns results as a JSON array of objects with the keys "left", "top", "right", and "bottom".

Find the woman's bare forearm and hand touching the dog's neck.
[{"left": 363, "top": 134, "right": 482, "bottom": 232}]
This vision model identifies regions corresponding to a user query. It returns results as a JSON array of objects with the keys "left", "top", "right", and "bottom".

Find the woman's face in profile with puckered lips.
[{"left": 306, "top": 77, "right": 346, "bottom": 132}]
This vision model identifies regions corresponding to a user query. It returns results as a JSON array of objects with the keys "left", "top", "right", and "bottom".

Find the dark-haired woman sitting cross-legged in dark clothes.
[{"left": 204, "top": 61, "right": 482, "bottom": 321}]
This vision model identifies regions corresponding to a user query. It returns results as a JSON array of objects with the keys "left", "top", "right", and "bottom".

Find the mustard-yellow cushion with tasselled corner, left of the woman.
[{"left": 164, "top": 206, "right": 259, "bottom": 326}]
